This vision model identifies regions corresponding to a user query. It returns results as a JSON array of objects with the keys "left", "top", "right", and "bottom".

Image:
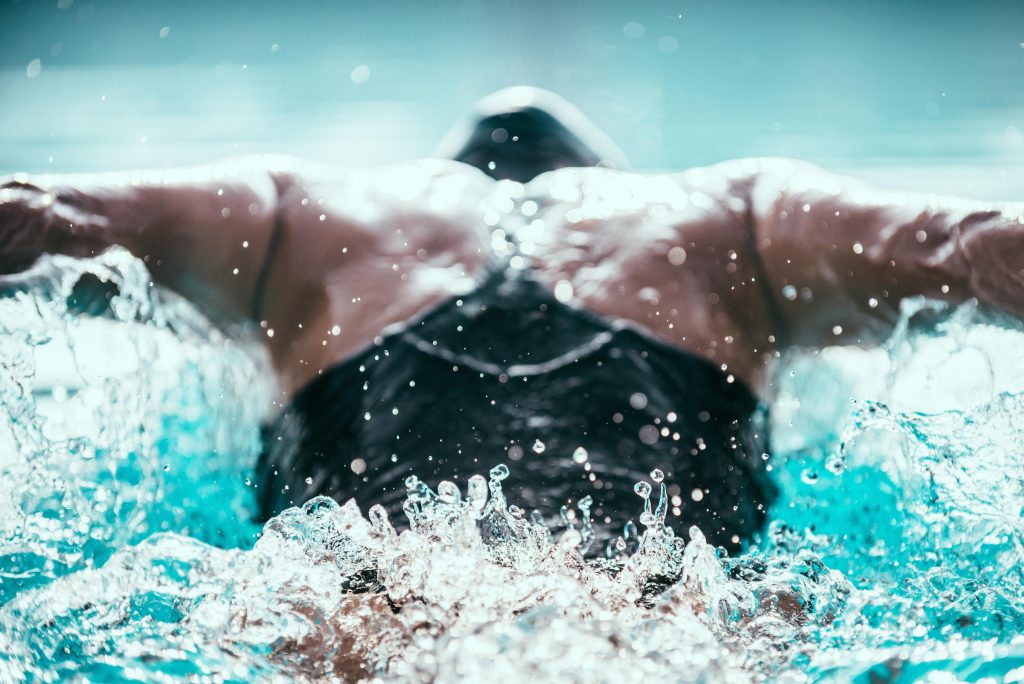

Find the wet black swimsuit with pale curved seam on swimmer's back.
[{"left": 259, "top": 255, "right": 774, "bottom": 549}]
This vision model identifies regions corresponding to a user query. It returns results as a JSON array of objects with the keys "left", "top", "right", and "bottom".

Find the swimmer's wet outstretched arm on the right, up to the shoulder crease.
[{"left": 751, "top": 160, "right": 1024, "bottom": 345}]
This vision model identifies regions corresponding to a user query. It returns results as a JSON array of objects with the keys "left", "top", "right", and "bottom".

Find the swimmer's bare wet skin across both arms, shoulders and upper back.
[{"left": 0, "top": 157, "right": 1024, "bottom": 403}]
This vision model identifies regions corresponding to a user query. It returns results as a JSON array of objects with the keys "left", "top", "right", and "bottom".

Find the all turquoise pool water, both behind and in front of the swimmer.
[{"left": 6, "top": 0, "right": 1024, "bottom": 683}]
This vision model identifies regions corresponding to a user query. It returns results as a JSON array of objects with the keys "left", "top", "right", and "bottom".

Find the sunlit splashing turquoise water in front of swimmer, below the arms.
[{"left": 0, "top": 251, "right": 1024, "bottom": 682}]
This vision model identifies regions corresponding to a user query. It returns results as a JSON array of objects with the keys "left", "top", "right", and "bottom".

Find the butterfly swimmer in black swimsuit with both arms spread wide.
[{"left": 0, "top": 88, "right": 1024, "bottom": 550}]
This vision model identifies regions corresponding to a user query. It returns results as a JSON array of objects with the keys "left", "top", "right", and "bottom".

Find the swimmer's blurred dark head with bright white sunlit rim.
[{"left": 437, "top": 86, "right": 626, "bottom": 182}]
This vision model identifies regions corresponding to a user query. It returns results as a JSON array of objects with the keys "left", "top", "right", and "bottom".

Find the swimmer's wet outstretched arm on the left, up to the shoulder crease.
[{"left": 0, "top": 158, "right": 303, "bottom": 322}]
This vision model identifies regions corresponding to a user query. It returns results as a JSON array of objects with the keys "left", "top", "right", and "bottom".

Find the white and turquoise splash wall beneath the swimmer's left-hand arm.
[{"left": 0, "top": 250, "right": 266, "bottom": 603}]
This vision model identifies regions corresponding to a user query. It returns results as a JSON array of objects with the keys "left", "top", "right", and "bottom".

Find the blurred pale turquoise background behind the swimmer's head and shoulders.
[{"left": 0, "top": 0, "right": 1024, "bottom": 199}]
